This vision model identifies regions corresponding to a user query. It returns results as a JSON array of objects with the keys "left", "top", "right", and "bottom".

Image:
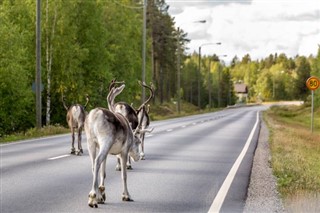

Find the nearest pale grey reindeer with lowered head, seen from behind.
[{"left": 85, "top": 84, "right": 152, "bottom": 208}]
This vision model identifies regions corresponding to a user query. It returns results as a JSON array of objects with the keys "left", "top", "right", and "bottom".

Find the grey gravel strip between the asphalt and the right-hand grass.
[{"left": 244, "top": 121, "right": 286, "bottom": 213}]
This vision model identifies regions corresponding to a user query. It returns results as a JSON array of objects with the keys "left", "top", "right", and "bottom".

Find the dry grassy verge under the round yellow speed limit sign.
[{"left": 264, "top": 106, "right": 320, "bottom": 212}]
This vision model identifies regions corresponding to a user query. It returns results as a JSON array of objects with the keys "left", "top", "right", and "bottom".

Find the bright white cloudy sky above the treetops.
[{"left": 166, "top": 0, "right": 320, "bottom": 63}]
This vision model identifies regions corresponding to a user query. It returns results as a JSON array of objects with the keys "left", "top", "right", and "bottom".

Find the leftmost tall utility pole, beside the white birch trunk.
[{"left": 36, "top": 0, "right": 42, "bottom": 129}]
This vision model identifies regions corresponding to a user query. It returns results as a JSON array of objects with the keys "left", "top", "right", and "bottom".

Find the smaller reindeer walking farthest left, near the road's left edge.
[{"left": 62, "top": 95, "right": 89, "bottom": 155}]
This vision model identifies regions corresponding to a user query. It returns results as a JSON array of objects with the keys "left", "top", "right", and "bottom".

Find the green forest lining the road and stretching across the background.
[{"left": 0, "top": 0, "right": 320, "bottom": 137}]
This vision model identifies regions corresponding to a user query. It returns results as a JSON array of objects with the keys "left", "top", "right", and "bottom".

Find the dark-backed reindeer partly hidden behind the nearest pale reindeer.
[{"left": 109, "top": 80, "right": 154, "bottom": 171}]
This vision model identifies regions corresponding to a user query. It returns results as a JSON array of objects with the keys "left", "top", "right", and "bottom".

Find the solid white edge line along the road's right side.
[{"left": 208, "top": 112, "right": 259, "bottom": 213}]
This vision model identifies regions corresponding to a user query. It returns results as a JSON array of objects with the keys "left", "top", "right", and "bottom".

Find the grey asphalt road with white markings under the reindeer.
[{"left": 0, "top": 106, "right": 264, "bottom": 213}]
